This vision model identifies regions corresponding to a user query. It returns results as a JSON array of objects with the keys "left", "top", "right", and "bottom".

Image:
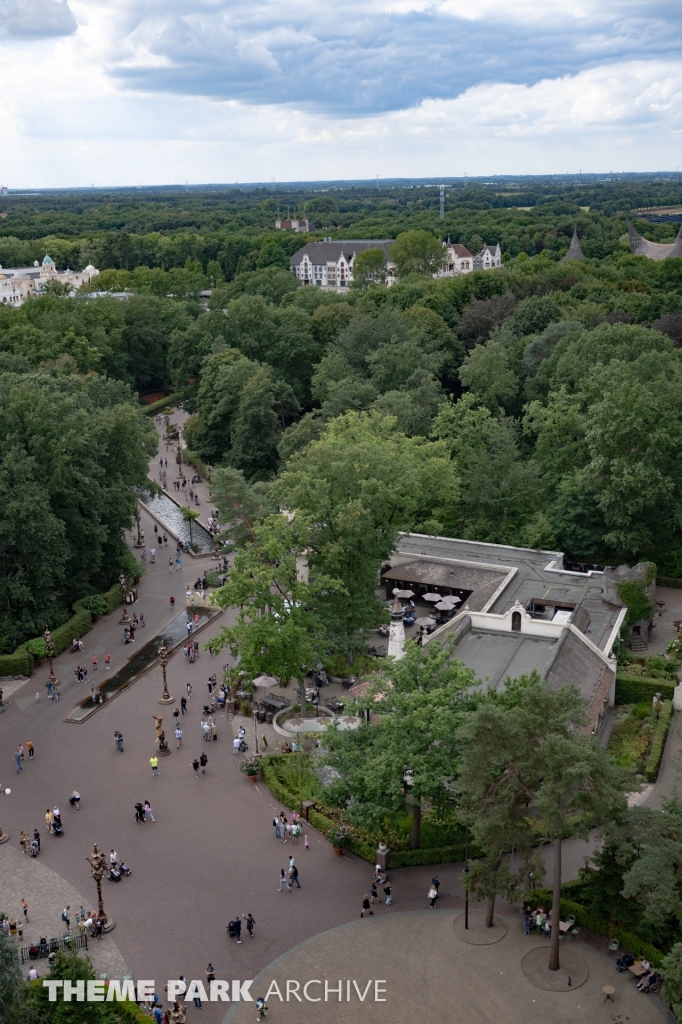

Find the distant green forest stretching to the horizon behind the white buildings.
[{"left": 0, "top": 175, "right": 682, "bottom": 282}]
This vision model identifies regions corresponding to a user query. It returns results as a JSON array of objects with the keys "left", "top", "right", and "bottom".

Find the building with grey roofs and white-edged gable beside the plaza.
[{"left": 381, "top": 534, "right": 627, "bottom": 733}]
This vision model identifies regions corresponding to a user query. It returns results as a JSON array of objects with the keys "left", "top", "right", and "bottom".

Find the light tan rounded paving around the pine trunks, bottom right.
[{"left": 223, "top": 913, "right": 673, "bottom": 1024}]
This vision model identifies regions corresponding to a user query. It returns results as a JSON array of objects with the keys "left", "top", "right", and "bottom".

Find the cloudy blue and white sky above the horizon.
[{"left": 0, "top": 0, "right": 682, "bottom": 187}]
